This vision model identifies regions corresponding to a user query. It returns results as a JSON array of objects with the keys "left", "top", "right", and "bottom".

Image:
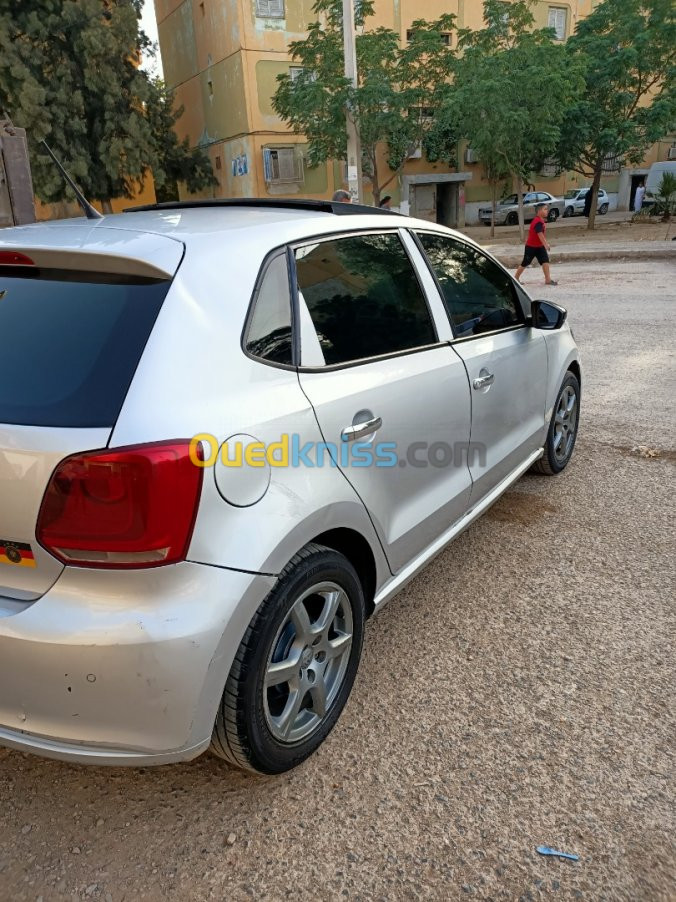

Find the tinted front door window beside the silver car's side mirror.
[{"left": 418, "top": 233, "right": 523, "bottom": 338}]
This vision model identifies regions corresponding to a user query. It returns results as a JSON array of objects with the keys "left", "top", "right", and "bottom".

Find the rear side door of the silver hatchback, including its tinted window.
[{"left": 293, "top": 230, "right": 471, "bottom": 573}]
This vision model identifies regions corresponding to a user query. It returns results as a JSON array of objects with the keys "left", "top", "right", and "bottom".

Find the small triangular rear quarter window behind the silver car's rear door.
[{"left": 246, "top": 254, "right": 293, "bottom": 363}]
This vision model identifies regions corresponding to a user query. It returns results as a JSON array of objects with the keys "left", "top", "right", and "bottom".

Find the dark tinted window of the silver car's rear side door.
[{"left": 296, "top": 234, "right": 437, "bottom": 364}]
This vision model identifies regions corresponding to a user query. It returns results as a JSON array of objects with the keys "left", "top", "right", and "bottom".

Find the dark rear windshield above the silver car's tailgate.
[{"left": 0, "top": 266, "right": 170, "bottom": 427}]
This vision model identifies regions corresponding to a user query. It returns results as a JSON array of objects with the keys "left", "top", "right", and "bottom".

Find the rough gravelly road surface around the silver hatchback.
[{"left": 0, "top": 263, "right": 676, "bottom": 902}]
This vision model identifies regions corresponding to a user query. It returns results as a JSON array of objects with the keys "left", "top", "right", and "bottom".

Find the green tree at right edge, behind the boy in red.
[{"left": 557, "top": 0, "right": 676, "bottom": 229}]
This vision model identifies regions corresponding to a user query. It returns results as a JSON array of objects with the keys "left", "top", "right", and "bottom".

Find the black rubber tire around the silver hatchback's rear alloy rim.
[{"left": 211, "top": 544, "right": 365, "bottom": 774}]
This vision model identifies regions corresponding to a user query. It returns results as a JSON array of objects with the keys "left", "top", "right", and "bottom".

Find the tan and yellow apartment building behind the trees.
[{"left": 155, "top": 0, "right": 670, "bottom": 226}]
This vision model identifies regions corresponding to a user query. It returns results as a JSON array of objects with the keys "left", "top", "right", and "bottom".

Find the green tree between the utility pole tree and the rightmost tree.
[{"left": 428, "top": 0, "right": 581, "bottom": 239}]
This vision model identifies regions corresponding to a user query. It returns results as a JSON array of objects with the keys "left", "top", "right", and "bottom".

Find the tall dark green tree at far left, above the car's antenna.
[{"left": 0, "top": 0, "right": 213, "bottom": 210}]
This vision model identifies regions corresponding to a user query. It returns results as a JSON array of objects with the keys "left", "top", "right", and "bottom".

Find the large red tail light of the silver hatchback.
[{"left": 37, "top": 441, "right": 203, "bottom": 568}]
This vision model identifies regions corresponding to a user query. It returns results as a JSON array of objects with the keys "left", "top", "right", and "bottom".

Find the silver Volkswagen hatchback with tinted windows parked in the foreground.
[{"left": 0, "top": 201, "right": 581, "bottom": 773}]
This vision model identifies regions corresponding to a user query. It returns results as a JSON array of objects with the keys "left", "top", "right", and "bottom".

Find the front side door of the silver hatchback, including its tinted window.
[{"left": 418, "top": 231, "right": 547, "bottom": 506}]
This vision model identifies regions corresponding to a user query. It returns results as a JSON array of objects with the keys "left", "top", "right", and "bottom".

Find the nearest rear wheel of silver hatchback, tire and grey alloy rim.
[{"left": 211, "top": 544, "right": 365, "bottom": 774}]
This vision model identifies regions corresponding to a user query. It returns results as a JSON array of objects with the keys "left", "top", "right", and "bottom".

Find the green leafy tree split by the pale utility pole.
[{"left": 273, "top": 0, "right": 455, "bottom": 204}]
